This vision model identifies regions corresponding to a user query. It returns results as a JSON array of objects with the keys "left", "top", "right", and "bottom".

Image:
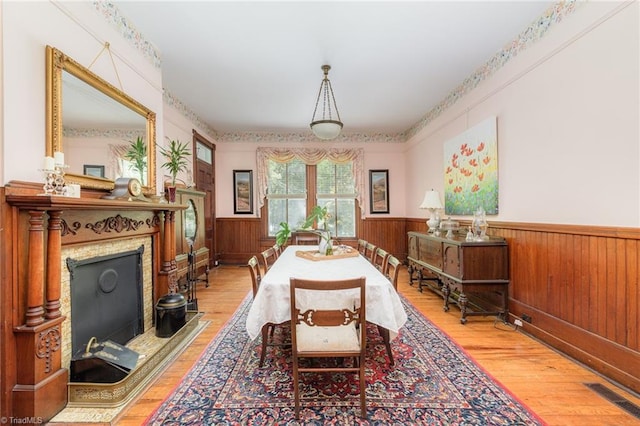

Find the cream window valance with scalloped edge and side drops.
[{"left": 256, "top": 148, "right": 364, "bottom": 217}]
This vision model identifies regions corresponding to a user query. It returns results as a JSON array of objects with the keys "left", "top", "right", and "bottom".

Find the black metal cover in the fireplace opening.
[{"left": 66, "top": 246, "right": 144, "bottom": 357}]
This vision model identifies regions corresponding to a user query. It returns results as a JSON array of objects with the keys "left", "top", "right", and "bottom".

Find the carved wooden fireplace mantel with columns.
[{"left": 2, "top": 185, "right": 186, "bottom": 422}]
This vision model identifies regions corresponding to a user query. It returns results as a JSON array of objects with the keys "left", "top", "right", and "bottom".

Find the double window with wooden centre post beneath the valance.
[{"left": 267, "top": 160, "right": 356, "bottom": 238}]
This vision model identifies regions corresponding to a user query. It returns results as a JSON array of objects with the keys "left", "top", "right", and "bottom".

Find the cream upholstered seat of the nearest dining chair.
[{"left": 296, "top": 323, "right": 360, "bottom": 354}]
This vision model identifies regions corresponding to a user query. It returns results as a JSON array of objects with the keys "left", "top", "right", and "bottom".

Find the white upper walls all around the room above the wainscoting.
[{"left": 0, "top": 1, "right": 640, "bottom": 227}]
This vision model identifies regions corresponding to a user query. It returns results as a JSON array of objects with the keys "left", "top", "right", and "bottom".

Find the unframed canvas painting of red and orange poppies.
[{"left": 444, "top": 117, "right": 498, "bottom": 215}]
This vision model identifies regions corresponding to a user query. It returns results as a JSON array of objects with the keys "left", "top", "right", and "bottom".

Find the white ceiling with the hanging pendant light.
[{"left": 112, "top": 0, "right": 553, "bottom": 134}]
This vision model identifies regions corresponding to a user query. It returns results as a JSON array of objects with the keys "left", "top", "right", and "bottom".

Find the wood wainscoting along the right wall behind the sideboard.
[{"left": 407, "top": 219, "right": 640, "bottom": 392}]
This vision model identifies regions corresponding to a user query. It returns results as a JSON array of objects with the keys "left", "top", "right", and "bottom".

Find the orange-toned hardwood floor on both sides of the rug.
[{"left": 115, "top": 266, "right": 640, "bottom": 426}]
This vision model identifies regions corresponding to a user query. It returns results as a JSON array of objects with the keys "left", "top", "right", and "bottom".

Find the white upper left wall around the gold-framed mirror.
[{"left": 0, "top": 1, "right": 163, "bottom": 191}]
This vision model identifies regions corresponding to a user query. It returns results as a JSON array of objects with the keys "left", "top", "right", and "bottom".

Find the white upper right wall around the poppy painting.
[{"left": 406, "top": 1, "right": 640, "bottom": 227}]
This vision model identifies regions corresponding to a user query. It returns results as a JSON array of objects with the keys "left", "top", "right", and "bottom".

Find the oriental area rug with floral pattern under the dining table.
[{"left": 145, "top": 296, "right": 544, "bottom": 425}]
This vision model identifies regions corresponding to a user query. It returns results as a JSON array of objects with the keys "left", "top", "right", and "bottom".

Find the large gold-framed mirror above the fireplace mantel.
[{"left": 46, "top": 46, "right": 156, "bottom": 195}]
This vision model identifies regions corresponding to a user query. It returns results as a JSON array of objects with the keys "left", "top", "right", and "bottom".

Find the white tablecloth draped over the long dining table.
[{"left": 247, "top": 246, "right": 407, "bottom": 339}]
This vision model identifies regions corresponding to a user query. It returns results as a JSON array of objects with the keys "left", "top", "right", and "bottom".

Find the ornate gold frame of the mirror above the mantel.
[{"left": 45, "top": 46, "right": 156, "bottom": 191}]
